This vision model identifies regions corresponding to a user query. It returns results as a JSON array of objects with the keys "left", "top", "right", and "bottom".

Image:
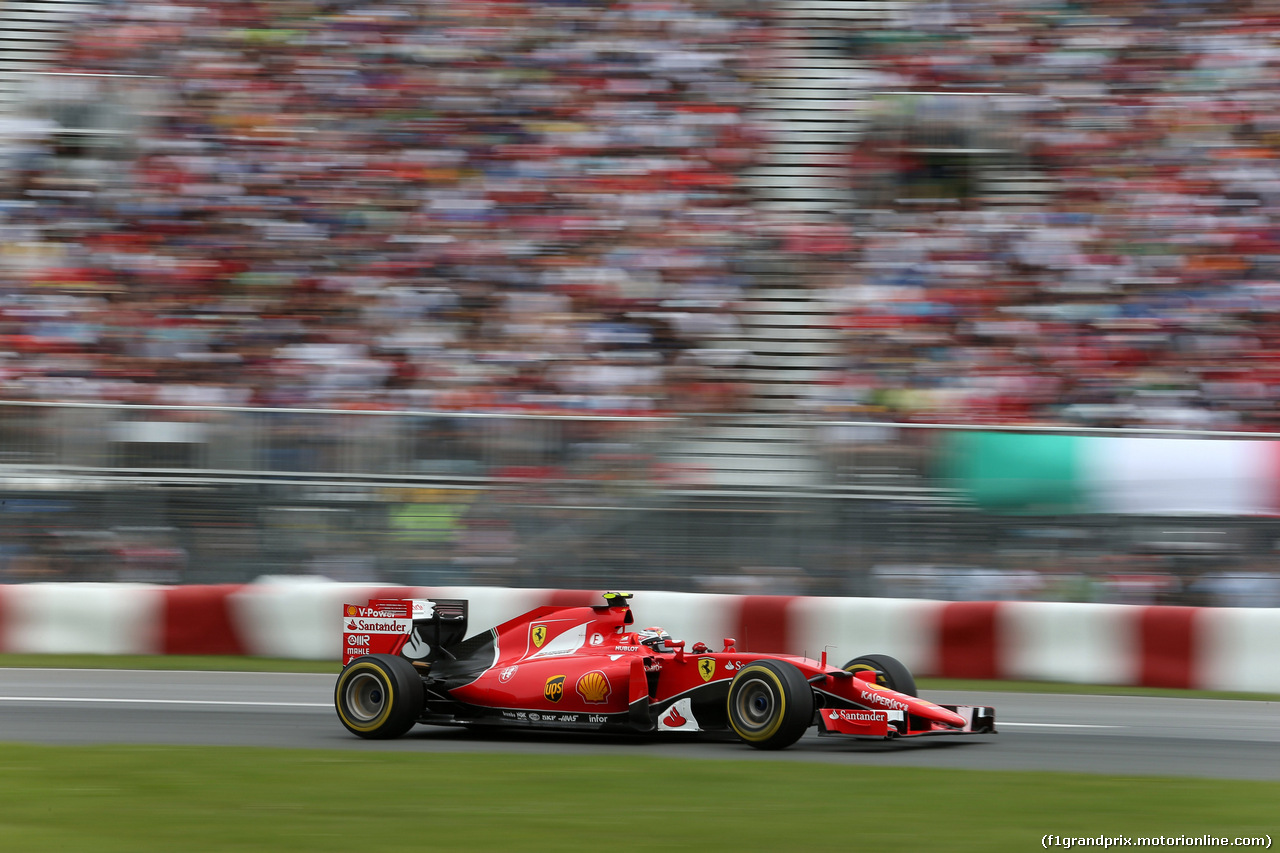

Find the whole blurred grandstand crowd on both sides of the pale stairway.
[{"left": 3, "top": 0, "right": 1280, "bottom": 430}]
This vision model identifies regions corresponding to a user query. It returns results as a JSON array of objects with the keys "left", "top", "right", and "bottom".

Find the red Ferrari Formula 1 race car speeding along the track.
[{"left": 334, "top": 593, "right": 996, "bottom": 749}]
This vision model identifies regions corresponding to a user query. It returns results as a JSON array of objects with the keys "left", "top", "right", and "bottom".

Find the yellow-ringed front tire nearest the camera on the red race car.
[{"left": 728, "top": 661, "right": 814, "bottom": 749}]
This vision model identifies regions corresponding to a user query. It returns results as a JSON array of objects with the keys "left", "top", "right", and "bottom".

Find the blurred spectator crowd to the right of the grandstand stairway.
[{"left": 819, "top": 0, "right": 1280, "bottom": 430}]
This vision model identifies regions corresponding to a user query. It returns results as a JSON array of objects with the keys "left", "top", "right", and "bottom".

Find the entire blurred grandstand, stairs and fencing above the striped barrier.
[{"left": 0, "top": 0, "right": 1280, "bottom": 606}]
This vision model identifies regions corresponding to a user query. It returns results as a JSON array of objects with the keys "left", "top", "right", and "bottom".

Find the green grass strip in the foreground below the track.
[{"left": 0, "top": 744, "right": 1280, "bottom": 853}]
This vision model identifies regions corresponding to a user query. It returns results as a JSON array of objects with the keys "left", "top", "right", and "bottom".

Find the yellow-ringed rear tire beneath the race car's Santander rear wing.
[{"left": 333, "top": 654, "right": 426, "bottom": 739}]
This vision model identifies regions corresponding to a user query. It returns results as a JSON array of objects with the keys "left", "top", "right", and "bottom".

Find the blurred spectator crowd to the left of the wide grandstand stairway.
[{"left": 0, "top": 0, "right": 769, "bottom": 414}]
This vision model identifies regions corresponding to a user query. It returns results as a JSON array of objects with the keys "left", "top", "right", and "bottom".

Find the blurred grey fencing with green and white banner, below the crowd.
[{"left": 0, "top": 402, "right": 1280, "bottom": 606}]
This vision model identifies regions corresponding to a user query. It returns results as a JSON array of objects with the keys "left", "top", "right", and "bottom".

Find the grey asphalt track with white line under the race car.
[{"left": 0, "top": 669, "right": 1280, "bottom": 780}]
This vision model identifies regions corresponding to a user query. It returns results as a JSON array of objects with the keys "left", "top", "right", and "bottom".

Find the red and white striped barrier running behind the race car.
[{"left": 0, "top": 578, "right": 1280, "bottom": 693}]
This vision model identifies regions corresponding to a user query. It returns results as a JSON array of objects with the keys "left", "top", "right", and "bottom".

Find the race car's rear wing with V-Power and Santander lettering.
[{"left": 342, "top": 598, "right": 467, "bottom": 666}]
